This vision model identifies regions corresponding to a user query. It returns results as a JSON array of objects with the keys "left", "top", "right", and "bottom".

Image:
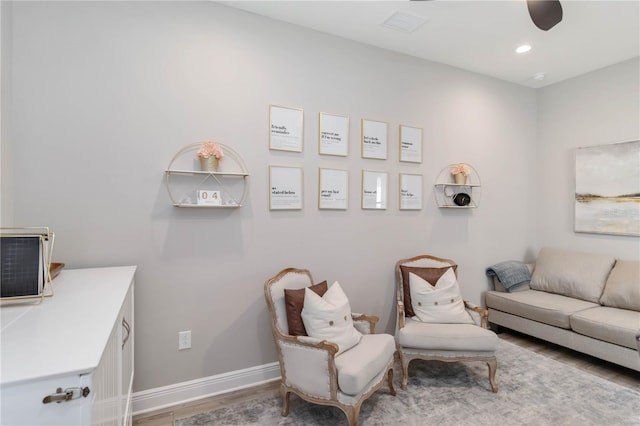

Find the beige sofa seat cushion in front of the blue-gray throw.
[{"left": 486, "top": 290, "right": 600, "bottom": 329}]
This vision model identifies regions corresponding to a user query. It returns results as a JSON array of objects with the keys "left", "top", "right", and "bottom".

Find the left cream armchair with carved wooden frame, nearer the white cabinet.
[{"left": 264, "top": 268, "right": 396, "bottom": 426}]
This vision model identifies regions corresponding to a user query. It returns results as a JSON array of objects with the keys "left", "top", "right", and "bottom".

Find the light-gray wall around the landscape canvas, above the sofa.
[{"left": 535, "top": 57, "right": 640, "bottom": 259}]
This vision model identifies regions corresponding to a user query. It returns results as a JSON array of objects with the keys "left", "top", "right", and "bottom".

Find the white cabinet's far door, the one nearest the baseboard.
[{"left": 120, "top": 284, "right": 134, "bottom": 426}]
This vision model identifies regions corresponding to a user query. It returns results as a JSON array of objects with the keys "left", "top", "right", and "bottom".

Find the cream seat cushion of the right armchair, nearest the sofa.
[{"left": 398, "top": 318, "right": 498, "bottom": 352}]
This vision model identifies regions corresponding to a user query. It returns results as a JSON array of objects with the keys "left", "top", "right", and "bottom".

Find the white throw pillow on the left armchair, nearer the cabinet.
[{"left": 302, "top": 281, "right": 362, "bottom": 355}]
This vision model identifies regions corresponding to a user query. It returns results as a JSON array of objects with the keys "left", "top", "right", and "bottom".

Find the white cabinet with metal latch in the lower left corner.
[{"left": 0, "top": 266, "right": 136, "bottom": 425}]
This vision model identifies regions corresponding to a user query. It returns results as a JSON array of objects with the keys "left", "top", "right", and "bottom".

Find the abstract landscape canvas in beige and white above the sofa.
[{"left": 574, "top": 141, "right": 640, "bottom": 236}]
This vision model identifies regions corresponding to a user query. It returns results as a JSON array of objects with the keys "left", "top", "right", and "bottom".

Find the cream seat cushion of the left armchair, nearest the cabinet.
[{"left": 335, "top": 334, "right": 396, "bottom": 395}]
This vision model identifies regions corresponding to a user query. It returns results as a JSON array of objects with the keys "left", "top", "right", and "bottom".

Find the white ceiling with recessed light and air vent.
[{"left": 219, "top": 0, "right": 640, "bottom": 88}]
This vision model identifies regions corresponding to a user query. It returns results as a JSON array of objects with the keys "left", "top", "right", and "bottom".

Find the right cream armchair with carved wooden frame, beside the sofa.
[{"left": 396, "top": 255, "right": 498, "bottom": 392}]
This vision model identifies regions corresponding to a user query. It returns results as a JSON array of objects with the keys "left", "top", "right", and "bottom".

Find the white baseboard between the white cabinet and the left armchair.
[{"left": 132, "top": 362, "right": 280, "bottom": 416}]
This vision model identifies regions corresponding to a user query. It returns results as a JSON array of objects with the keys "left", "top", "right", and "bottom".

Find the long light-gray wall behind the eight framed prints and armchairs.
[{"left": 3, "top": 2, "right": 638, "bottom": 391}]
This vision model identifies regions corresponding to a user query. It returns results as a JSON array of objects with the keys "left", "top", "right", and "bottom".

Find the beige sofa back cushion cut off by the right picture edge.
[{"left": 600, "top": 260, "right": 640, "bottom": 312}]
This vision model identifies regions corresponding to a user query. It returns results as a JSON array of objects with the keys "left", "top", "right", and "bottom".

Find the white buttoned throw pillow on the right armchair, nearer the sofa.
[{"left": 409, "top": 268, "right": 474, "bottom": 324}]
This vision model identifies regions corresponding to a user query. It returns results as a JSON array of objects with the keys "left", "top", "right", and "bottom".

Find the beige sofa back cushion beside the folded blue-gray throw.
[{"left": 530, "top": 247, "right": 615, "bottom": 302}]
